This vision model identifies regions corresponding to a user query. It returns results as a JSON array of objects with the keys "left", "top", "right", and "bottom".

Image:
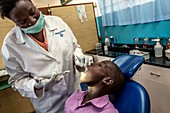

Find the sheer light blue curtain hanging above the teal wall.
[{"left": 98, "top": 0, "right": 170, "bottom": 26}]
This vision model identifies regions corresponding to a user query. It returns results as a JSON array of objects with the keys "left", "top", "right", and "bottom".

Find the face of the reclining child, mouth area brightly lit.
[{"left": 80, "top": 61, "right": 112, "bottom": 84}]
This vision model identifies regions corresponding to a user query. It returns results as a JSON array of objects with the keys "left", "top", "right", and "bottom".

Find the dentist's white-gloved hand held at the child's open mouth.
[{"left": 75, "top": 55, "right": 89, "bottom": 67}]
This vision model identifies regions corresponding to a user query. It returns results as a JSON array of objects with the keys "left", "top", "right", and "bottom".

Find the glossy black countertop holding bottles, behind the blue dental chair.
[{"left": 85, "top": 49, "right": 170, "bottom": 68}]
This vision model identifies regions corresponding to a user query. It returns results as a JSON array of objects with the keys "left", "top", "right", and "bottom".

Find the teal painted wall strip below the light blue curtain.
[{"left": 97, "top": 17, "right": 170, "bottom": 45}]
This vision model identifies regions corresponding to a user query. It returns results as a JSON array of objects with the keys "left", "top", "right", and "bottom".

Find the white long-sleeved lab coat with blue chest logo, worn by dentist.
[{"left": 1, "top": 16, "right": 83, "bottom": 113}]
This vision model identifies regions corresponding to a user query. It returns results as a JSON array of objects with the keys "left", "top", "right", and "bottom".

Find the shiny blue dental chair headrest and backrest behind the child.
[{"left": 110, "top": 55, "right": 150, "bottom": 113}]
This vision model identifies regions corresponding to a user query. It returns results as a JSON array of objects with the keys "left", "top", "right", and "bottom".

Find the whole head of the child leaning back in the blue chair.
[{"left": 80, "top": 60, "right": 125, "bottom": 93}]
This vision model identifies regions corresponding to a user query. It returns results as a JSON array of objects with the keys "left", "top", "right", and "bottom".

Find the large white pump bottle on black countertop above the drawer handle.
[{"left": 154, "top": 41, "right": 163, "bottom": 57}]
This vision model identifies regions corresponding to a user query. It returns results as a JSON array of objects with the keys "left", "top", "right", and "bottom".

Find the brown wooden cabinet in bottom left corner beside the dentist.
[{"left": 0, "top": 88, "right": 34, "bottom": 113}]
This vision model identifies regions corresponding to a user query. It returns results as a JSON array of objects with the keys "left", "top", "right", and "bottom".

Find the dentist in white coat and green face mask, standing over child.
[{"left": 0, "top": 0, "right": 88, "bottom": 113}]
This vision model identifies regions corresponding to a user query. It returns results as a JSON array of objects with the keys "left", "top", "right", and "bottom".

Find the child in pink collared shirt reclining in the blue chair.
[{"left": 65, "top": 60, "right": 124, "bottom": 113}]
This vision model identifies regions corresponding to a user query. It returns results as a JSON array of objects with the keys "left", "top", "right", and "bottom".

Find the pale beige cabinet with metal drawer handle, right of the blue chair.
[{"left": 133, "top": 64, "right": 170, "bottom": 113}]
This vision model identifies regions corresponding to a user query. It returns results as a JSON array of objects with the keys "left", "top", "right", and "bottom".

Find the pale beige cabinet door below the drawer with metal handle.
[{"left": 140, "top": 78, "right": 170, "bottom": 113}]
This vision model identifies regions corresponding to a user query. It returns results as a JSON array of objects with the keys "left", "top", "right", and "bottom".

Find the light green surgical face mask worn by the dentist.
[{"left": 21, "top": 12, "right": 44, "bottom": 34}]
